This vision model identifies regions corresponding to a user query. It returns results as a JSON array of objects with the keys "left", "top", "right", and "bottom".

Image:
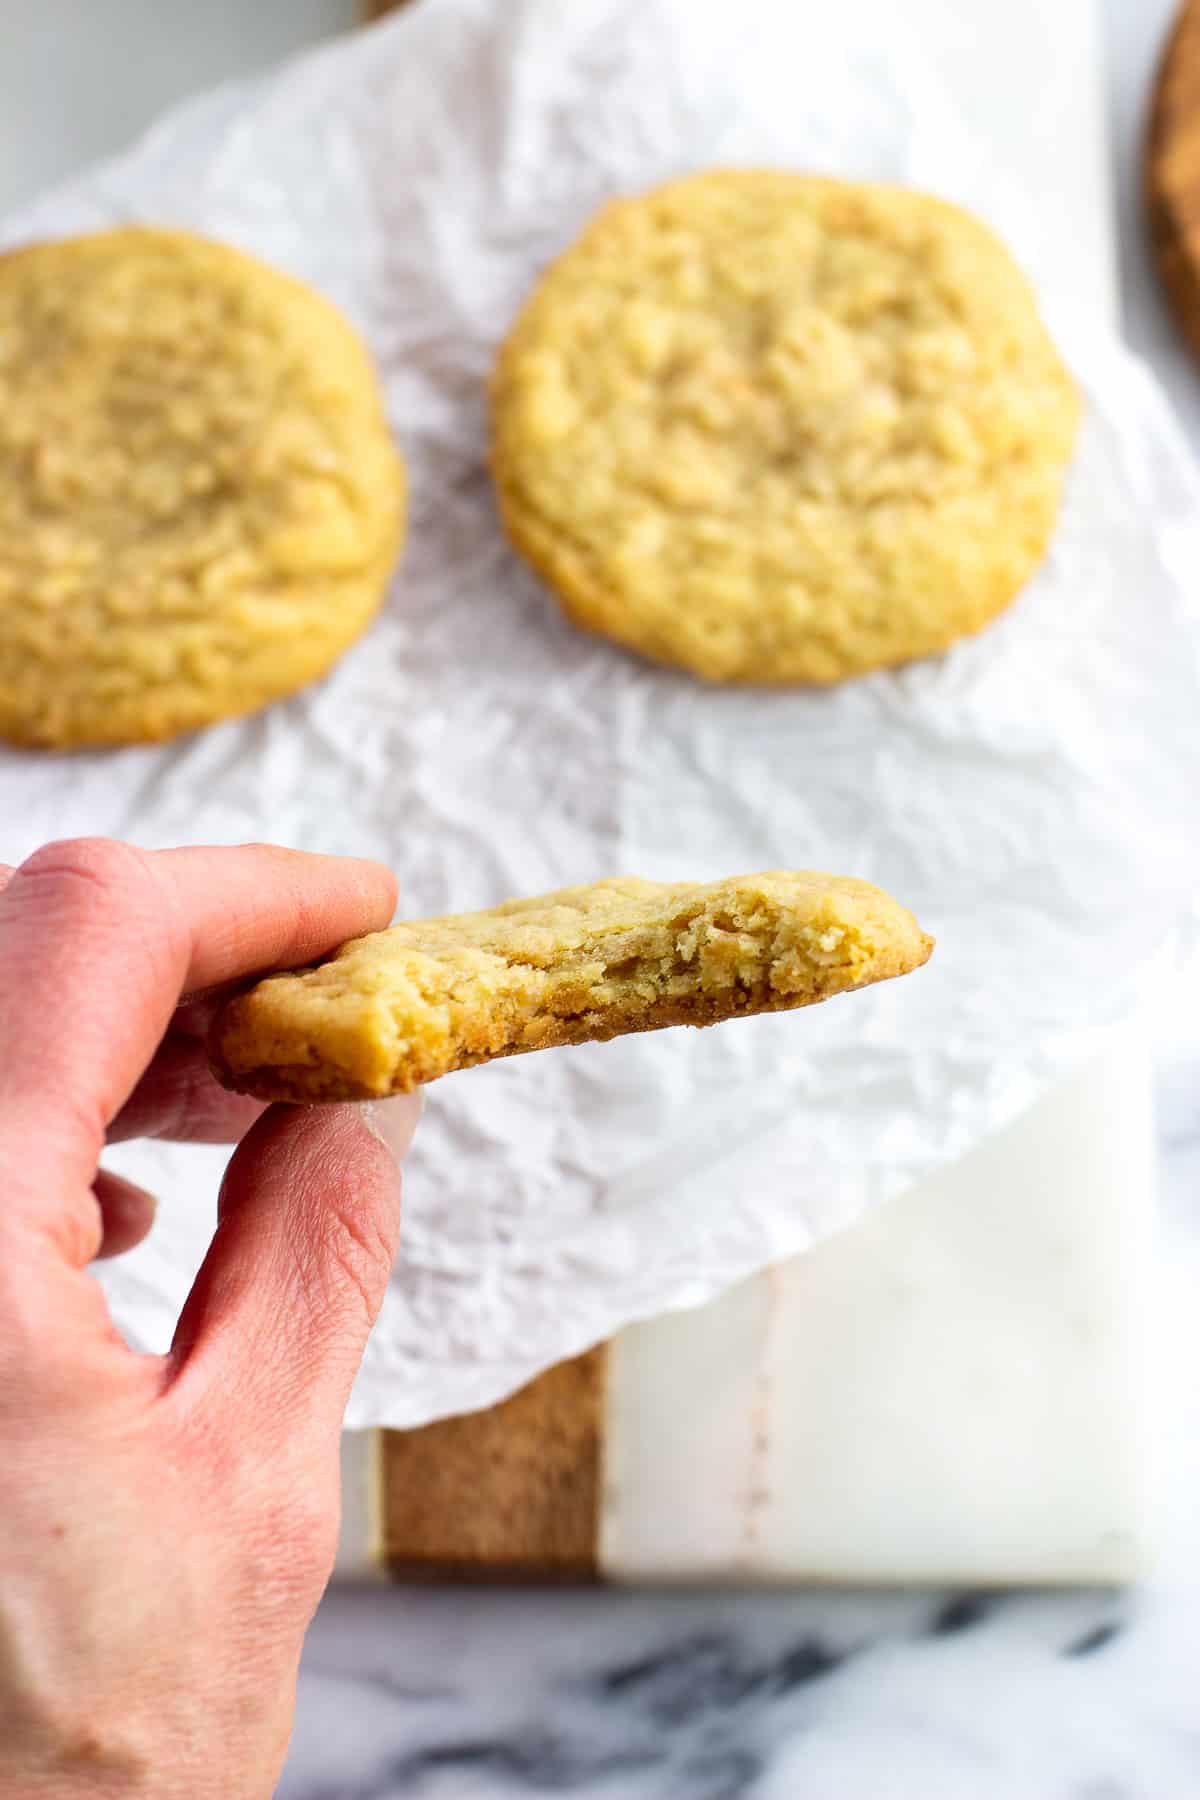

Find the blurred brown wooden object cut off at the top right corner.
[{"left": 1142, "top": 0, "right": 1200, "bottom": 355}]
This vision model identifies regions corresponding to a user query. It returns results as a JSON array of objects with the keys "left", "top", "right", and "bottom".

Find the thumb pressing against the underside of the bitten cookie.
[{"left": 171, "top": 1094, "right": 419, "bottom": 1449}]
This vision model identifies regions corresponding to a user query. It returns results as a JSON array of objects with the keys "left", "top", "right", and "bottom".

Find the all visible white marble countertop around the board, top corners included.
[{"left": 9, "top": 0, "right": 1200, "bottom": 1800}]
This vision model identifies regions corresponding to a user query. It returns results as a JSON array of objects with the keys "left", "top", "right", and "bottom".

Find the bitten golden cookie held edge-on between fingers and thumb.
[{"left": 209, "top": 871, "right": 934, "bottom": 1100}]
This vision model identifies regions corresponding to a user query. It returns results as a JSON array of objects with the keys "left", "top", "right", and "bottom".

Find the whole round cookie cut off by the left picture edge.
[{"left": 0, "top": 227, "right": 405, "bottom": 747}]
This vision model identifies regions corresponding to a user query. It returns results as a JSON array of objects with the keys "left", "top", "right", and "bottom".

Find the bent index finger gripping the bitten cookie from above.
[{"left": 0, "top": 839, "right": 396, "bottom": 1260}]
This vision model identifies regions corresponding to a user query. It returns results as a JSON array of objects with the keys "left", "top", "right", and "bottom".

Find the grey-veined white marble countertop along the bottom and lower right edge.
[{"left": 287, "top": 1108, "right": 1200, "bottom": 1800}]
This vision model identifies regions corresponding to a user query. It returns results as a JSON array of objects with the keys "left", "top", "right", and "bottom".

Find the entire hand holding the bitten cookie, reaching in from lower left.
[{"left": 0, "top": 839, "right": 417, "bottom": 1800}]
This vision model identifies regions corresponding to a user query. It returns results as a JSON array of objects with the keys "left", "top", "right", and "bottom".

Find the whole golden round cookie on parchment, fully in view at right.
[{"left": 491, "top": 169, "right": 1078, "bottom": 682}]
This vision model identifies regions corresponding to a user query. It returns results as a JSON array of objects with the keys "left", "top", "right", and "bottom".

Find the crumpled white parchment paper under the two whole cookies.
[{"left": 0, "top": 0, "right": 1200, "bottom": 1424}]
